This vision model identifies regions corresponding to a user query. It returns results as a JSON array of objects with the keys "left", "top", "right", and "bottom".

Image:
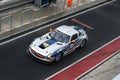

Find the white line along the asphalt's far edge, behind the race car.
[{"left": 0, "top": 0, "right": 116, "bottom": 46}]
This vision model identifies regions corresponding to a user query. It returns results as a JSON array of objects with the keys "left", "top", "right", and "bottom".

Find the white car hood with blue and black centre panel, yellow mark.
[{"left": 30, "top": 38, "right": 66, "bottom": 56}]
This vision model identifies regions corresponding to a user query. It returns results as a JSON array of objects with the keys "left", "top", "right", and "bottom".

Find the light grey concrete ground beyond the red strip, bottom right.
[{"left": 78, "top": 52, "right": 120, "bottom": 80}]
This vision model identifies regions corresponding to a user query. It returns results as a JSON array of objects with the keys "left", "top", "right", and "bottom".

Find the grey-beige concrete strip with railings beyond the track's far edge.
[{"left": 0, "top": 0, "right": 106, "bottom": 39}]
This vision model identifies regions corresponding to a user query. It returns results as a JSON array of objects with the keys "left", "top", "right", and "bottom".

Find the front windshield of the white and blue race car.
[{"left": 50, "top": 30, "right": 70, "bottom": 43}]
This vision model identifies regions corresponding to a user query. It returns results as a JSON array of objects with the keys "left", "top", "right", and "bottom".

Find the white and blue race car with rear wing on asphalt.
[{"left": 28, "top": 19, "right": 92, "bottom": 63}]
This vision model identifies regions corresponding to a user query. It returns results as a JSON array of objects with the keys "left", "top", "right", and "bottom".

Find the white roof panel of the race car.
[{"left": 57, "top": 25, "right": 78, "bottom": 36}]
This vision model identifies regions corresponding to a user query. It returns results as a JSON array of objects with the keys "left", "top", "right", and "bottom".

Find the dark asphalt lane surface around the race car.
[{"left": 0, "top": 1, "right": 120, "bottom": 80}]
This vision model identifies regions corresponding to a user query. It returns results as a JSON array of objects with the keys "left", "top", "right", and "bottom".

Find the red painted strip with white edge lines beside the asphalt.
[{"left": 45, "top": 36, "right": 120, "bottom": 80}]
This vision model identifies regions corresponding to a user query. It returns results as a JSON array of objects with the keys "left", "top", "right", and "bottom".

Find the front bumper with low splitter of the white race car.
[{"left": 27, "top": 48, "right": 54, "bottom": 63}]
